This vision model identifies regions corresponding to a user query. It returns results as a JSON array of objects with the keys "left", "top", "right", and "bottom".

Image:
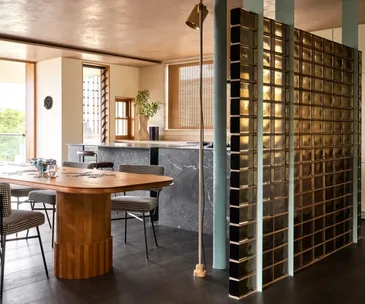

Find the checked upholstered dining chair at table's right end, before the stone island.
[{"left": 111, "top": 165, "right": 164, "bottom": 260}]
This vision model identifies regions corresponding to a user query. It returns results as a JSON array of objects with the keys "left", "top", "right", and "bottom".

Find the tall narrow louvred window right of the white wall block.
[{"left": 83, "top": 65, "right": 108, "bottom": 143}]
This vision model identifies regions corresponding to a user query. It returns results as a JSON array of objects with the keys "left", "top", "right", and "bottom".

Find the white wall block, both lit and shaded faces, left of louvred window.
[{"left": 36, "top": 58, "right": 82, "bottom": 164}]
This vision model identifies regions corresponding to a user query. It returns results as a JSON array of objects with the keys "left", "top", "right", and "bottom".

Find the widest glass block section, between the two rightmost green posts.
[{"left": 294, "top": 30, "right": 354, "bottom": 270}]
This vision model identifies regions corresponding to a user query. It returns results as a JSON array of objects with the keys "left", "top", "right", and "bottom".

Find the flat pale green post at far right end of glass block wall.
[{"left": 342, "top": 0, "right": 359, "bottom": 243}]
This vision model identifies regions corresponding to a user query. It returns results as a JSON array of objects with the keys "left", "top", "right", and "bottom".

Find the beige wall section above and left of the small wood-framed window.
[{"left": 109, "top": 65, "right": 140, "bottom": 142}]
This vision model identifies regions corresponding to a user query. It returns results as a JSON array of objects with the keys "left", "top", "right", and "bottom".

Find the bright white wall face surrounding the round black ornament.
[{"left": 36, "top": 58, "right": 62, "bottom": 162}]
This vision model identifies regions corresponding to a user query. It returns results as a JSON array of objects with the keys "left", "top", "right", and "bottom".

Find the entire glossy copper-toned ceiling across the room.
[{"left": 0, "top": 0, "right": 365, "bottom": 66}]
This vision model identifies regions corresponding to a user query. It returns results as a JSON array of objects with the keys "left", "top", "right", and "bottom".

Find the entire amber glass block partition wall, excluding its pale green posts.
[{"left": 229, "top": 9, "right": 361, "bottom": 298}]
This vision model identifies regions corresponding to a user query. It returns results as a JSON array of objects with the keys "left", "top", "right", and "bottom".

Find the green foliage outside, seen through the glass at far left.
[{"left": 0, "top": 108, "right": 25, "bottom": 161}]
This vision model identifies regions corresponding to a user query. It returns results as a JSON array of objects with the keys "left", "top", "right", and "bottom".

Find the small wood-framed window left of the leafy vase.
[{"left": 115, "top": 97, "right": 134, "bottom": 139}]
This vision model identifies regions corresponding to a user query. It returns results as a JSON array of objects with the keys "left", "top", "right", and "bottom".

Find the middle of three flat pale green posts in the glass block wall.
[{"left": 275, "top": 0, "right": 294, "bottom": 276}]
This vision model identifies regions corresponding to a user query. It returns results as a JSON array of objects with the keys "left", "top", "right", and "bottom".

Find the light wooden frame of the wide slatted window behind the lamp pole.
[{"left": 167, "top": 60, "right": 213, "bottom": 130}]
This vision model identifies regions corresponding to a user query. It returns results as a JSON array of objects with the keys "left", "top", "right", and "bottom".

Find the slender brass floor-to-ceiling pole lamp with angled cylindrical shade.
[{"left": 185, "top": 0, "right": 208, "bottom": 278}]
